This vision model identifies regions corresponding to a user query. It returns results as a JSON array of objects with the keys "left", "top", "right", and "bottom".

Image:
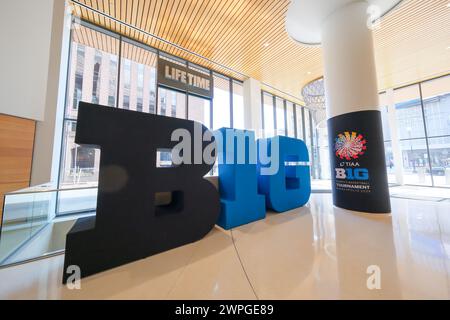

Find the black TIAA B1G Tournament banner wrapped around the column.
[{"left": 328, "top": 111, "right": 391, "bottom": 213}]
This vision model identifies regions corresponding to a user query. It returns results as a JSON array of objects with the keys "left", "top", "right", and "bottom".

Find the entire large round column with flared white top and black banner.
[{"left": 286, "top": 0, "right": 400, "bottom": 213}]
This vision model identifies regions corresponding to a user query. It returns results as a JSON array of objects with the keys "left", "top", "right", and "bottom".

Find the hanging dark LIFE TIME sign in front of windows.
[{"left": 158, "top": 58, "right": 213, "bottom": 99}]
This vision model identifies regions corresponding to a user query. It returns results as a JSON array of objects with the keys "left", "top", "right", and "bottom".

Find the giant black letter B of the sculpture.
[{"left": 63, "top": 103, "right": 220, "bottom": 282}]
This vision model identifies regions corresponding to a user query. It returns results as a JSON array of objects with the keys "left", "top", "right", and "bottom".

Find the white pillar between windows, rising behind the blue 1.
[{"left": 244, "top": 78, "right": 262, "bottom": 138}]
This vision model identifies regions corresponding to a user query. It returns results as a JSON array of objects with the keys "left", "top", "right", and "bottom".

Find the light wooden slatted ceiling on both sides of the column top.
[{"left": 69, "top": 0, "right": 450, "bottom": 98}]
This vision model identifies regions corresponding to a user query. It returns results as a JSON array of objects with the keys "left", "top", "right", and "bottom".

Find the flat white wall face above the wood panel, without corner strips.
[{"left": 0, "top": 0, "right": 55, "bottom": 120}]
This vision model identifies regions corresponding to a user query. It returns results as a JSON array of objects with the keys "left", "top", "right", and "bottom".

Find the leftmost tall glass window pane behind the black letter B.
[{"left": 59, "top": 26, "right": 119, "bottom": 192}]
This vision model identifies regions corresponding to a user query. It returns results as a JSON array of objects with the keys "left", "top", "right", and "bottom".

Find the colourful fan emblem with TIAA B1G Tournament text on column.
[{"left": 334, "top": 131, "right": 370, "bottom": 192}]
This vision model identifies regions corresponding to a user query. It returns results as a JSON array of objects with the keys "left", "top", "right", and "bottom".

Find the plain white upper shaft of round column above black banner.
[{"left": 322, "top": 1, "right": 379, "bottom": 118}]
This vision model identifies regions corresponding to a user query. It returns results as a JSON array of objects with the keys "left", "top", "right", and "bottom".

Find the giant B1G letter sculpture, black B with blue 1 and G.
[{"left": 63, "top": 103, "right": 311, "bottom": 282}]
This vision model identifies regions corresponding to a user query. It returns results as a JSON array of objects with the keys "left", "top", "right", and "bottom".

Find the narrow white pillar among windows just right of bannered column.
[{"left": 386, "top": 89, "right": 405, "bottom": 185}]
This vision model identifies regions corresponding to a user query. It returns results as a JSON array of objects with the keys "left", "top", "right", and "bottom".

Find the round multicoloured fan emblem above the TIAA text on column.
[{"left": 334, "top": 132, "right": 367, "bottom": 161}]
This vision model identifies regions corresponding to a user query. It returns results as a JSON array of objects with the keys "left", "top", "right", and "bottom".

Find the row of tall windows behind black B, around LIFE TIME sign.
[{"left": 58, "top": 23, "right": 245, "bottom": 214}]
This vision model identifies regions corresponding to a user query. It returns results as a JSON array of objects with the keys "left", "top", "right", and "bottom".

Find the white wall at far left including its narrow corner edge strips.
[{"left": 0, "top": 0, "right": 70, "bottom": 185}]
